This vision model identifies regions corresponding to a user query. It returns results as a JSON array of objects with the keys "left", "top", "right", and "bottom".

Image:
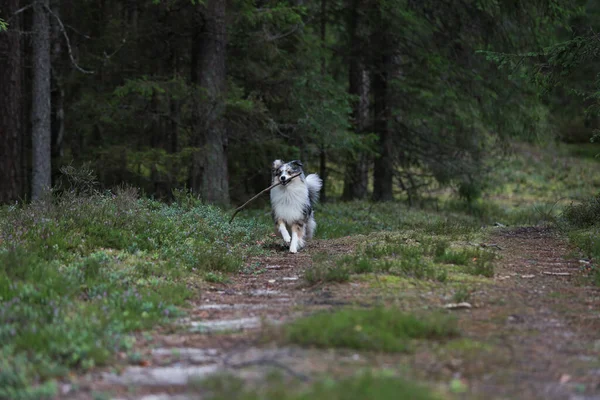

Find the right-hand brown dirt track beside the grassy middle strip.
[{"left": 461, "top": 228, "right": 600, "bottom": 399}]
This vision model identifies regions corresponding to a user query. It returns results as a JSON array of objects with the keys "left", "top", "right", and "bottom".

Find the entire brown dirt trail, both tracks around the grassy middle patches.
[{"left": 65, "top": 228, "right": 600, "bottom": 400}]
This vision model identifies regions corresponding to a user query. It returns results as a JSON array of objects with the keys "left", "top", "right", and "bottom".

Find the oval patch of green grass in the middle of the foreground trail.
[{"left": 284, "top": 307, "right": 458, "bottom": 352}]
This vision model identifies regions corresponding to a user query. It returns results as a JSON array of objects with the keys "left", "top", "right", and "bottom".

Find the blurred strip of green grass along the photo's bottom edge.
[{"left": 202, "top": 371, "right": 440, "bottom": 400}]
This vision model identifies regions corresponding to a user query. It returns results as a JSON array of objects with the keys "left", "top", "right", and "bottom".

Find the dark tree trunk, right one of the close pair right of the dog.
[{"left": 372, "top": 13, "right": 394, "bottom": 201}]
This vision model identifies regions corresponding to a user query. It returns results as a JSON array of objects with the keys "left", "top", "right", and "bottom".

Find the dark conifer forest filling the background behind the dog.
[{"left": 0, "top": 0, "right": 600, "bottom": 205}]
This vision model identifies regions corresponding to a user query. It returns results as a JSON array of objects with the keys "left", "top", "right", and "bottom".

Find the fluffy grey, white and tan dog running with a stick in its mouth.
[{"left": 271, "top": 160, "right": 323, "bottom": 253}]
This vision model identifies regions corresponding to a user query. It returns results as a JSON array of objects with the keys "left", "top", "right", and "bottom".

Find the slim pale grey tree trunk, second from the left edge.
[{"left": 31, "top": 0, "right": 52, "bottom": 200}]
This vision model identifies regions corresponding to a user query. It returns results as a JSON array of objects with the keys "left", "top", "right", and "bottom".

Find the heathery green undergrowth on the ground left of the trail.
[{"left": 0, "top": 189, "right": 268, "bottom": 399}]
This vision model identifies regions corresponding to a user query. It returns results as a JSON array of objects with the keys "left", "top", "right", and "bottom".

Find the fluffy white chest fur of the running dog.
[{"left": 271, "top": 181, "right": 309, "bottom": 224}]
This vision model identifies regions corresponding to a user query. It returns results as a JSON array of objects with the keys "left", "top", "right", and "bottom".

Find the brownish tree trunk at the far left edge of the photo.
[{"left": 0, "top": 0, "right": 25, "bottom": 204}]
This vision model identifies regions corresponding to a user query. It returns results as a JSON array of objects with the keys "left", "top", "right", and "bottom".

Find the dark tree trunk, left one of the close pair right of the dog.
[{"left": 342, "top": 0, "right": 369, "bottom": 200}]
